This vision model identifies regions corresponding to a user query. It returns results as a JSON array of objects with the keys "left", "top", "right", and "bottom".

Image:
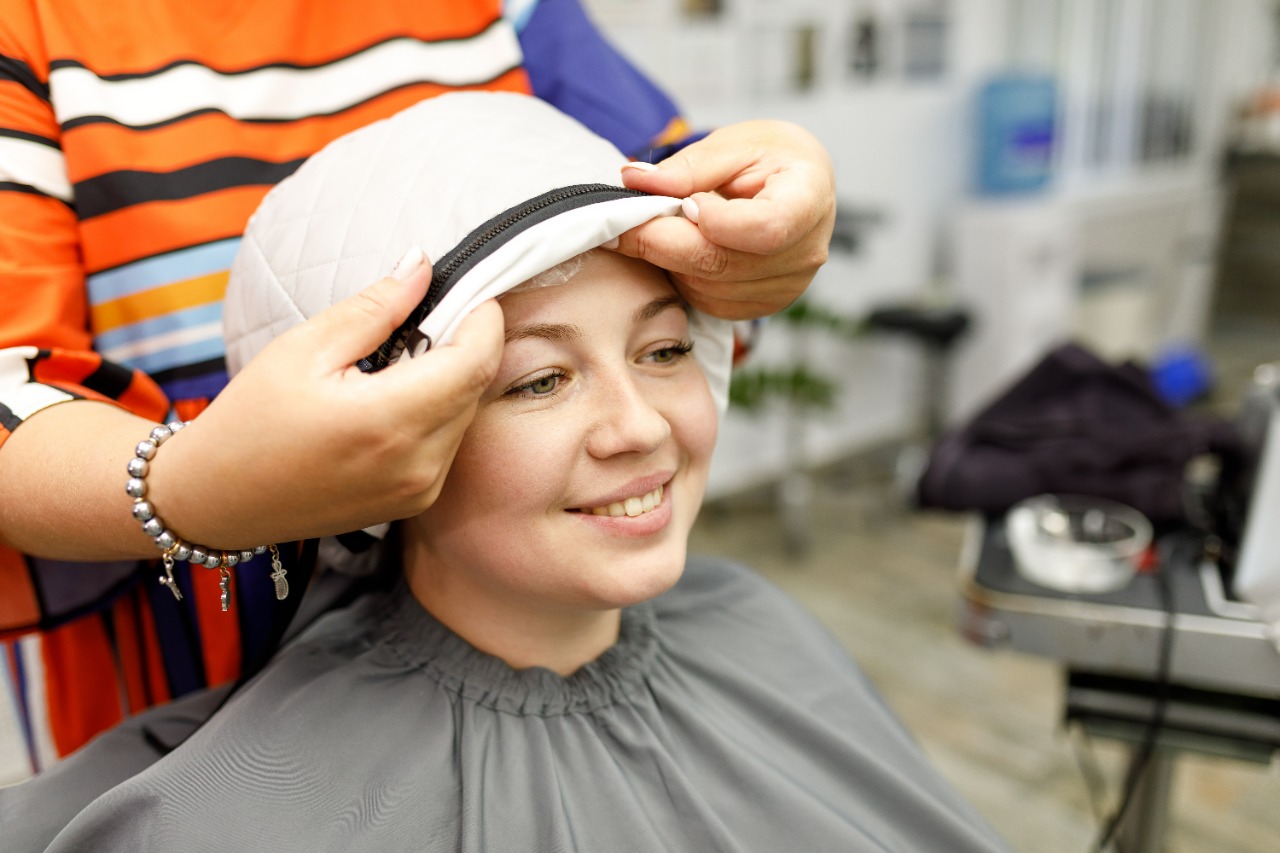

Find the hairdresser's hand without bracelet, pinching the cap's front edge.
[{"left": 618, "top": 120, "right": 836, "bottom": 320}]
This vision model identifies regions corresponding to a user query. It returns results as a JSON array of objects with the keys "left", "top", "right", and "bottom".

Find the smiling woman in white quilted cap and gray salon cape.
[{"left": 0, "top": 95, "right": 1002, "bottom": 853}]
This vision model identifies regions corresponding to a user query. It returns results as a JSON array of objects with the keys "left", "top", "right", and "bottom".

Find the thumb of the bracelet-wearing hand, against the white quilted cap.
[{"left": 300, "top": 248, "right": 431, "bottom": 368}]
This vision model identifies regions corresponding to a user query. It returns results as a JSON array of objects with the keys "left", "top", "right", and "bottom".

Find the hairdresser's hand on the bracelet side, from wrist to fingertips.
[{"left": 148, "top": 252, "right": 503, "bottom": 548}]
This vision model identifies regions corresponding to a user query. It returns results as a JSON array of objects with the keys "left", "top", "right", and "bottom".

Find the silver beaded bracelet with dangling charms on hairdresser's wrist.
[{"left": 124, "top": 420, "right": 289, "bottom": 612}]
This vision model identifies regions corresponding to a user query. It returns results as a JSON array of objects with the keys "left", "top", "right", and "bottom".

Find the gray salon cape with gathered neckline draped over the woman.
[{"left": 12, "top": 558, "right": 1004, "bottom": 853}]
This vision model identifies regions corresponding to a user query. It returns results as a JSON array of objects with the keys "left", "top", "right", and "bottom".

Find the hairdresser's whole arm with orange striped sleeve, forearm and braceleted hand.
[{"left": 0, "top": 4, "right": 502, "bottom": 567}]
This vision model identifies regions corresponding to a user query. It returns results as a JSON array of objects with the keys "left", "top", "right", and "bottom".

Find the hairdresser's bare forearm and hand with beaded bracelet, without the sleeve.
[{"left": 0, "top": 252, "right": 502, "bottom": 560}]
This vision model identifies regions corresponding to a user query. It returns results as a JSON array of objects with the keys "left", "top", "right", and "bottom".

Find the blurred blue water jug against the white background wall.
[{"left": 977, "top": 72, "right": 1057, "bottom": 196}]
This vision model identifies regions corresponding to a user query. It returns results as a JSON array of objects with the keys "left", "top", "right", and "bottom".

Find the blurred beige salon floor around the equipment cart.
[{"left": 694, "top": 307, "right": 1280, "bottom": 853}]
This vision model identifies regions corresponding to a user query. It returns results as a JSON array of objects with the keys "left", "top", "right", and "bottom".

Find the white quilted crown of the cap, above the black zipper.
[{"left": 224, "top": 92, "right": 625, "bottom": 371}]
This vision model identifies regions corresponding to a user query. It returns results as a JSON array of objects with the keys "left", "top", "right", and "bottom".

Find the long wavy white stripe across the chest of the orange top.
[{"left": 49, "top": 22, "right": 521, "bottom": 127}]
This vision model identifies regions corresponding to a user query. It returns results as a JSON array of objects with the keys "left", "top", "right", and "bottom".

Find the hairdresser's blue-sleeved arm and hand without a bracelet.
[{"left": 513, "top": 0, "right": 836, "bottom": 320}]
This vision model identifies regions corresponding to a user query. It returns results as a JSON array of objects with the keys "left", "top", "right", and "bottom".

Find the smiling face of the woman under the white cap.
[{"left": 410, "top": 251, "right": 717, "bottom": 615}]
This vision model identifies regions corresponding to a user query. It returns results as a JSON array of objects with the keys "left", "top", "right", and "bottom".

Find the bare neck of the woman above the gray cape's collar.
[{"left": 403, "top": 535, "right": 621, "bottom": 675}]
